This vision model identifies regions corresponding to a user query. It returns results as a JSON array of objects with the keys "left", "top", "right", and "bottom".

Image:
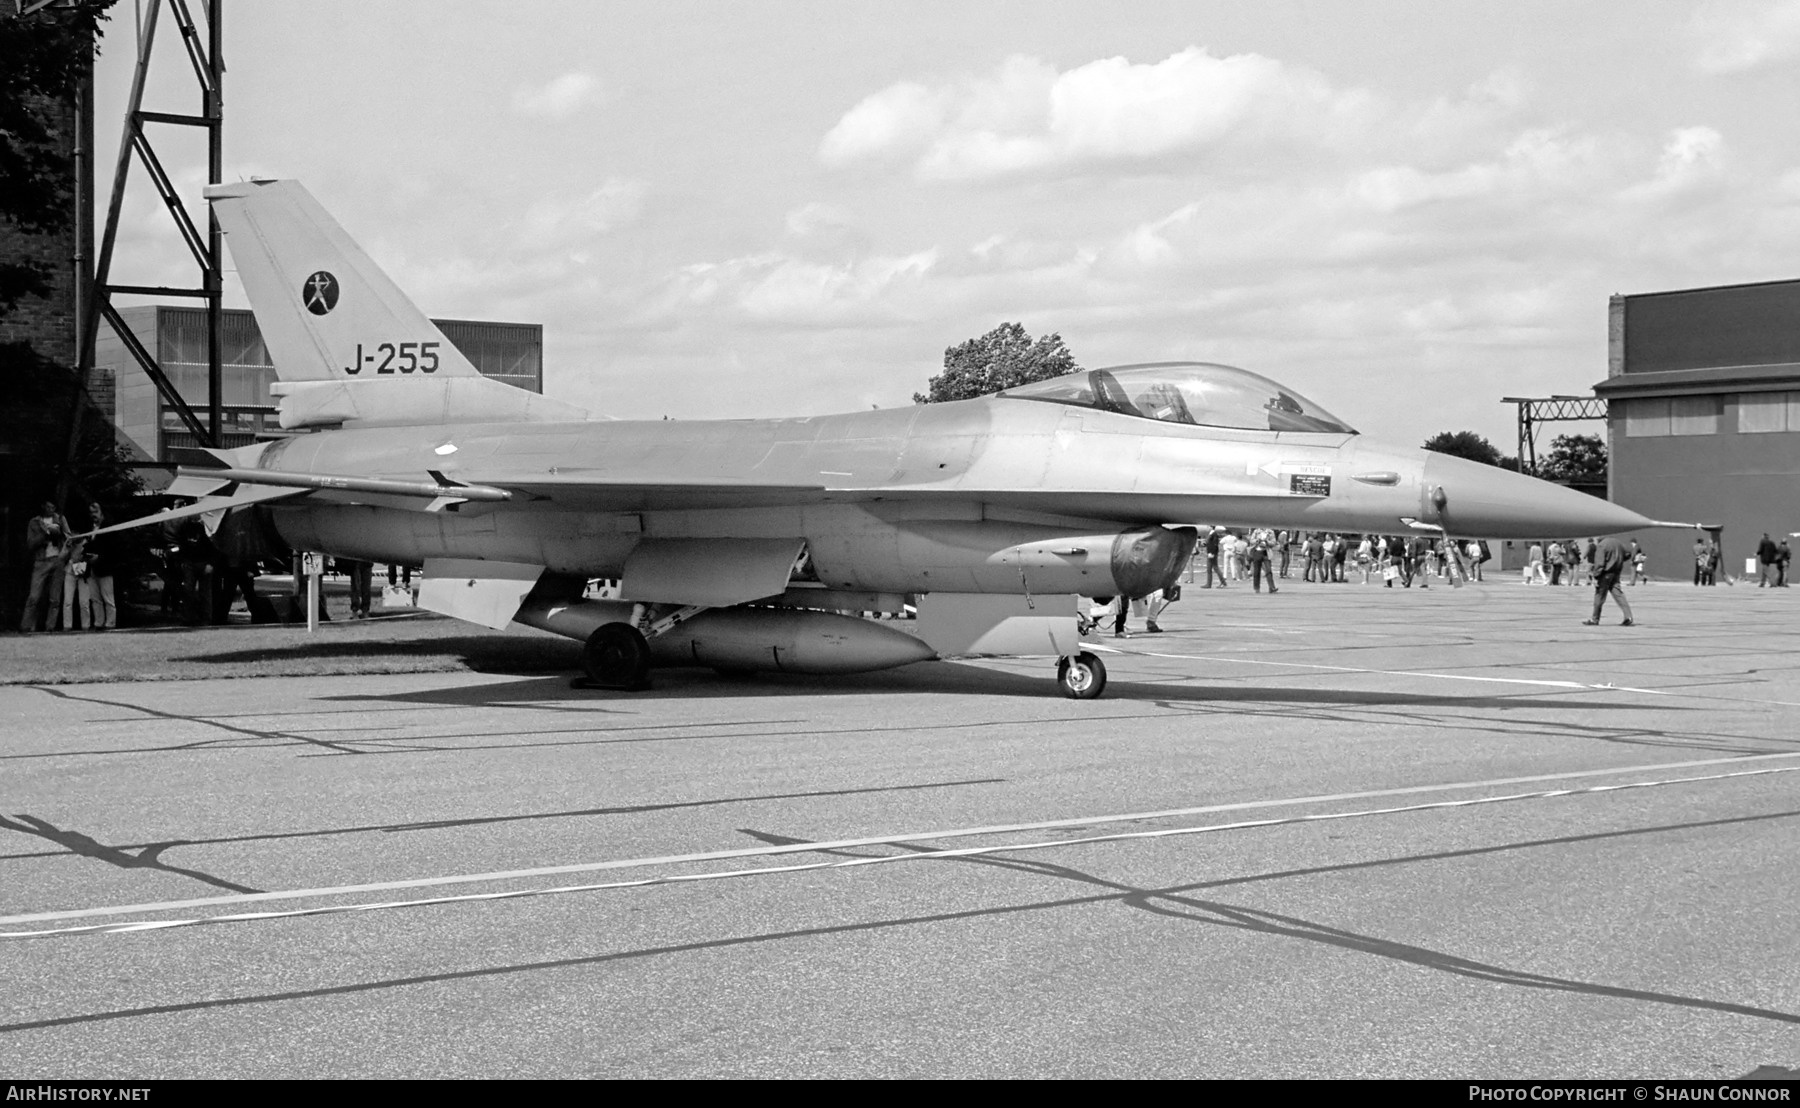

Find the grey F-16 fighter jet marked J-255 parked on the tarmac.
[{"left": 91, "top": 180, "right": 1651, "bottom": 698}]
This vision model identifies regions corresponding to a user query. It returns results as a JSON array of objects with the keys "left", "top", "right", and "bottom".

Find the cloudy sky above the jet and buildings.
[{"left": 97, "top": 0, "right": 1800, "bottom": 453}]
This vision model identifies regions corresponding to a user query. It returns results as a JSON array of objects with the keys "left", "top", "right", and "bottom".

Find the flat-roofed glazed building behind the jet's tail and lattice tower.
[{"left": 88, "top": 304, "right": 544, "bottom": 462}]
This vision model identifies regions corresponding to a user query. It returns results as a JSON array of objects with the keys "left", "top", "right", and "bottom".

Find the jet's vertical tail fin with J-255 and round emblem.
[{"left": 205, "top": 180, "right": 479, "bottom": 381}]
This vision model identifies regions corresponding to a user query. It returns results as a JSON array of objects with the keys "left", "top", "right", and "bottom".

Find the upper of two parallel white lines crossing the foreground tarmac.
[{"left": 0, "top": 750, "right": 1800, "bottom": 925}]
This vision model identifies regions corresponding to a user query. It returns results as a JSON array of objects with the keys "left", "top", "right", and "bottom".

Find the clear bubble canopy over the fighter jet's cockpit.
[{"left": 995, "top": 362, "right": 1355, "bottom": 435}]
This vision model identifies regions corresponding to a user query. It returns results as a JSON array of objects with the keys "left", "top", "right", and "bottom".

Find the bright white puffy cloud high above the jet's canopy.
[{"left": 819, "top": 47, "right": 1368, "bottom": 180}]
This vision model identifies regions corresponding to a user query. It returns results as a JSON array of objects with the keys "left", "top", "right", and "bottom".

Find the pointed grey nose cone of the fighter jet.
[{"left": 1426, "top": 453, "right": 1654, "bottom": 538}]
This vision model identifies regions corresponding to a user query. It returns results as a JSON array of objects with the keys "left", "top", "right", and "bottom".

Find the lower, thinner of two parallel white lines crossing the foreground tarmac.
[{"left": 0, "top": 766, "right": 1800, "bottom": 939}]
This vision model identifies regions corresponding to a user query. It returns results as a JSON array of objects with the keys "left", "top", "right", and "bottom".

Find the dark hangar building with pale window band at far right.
[{"left": 1595, "top": 281, "right": 1800, "bottom": 579}]
